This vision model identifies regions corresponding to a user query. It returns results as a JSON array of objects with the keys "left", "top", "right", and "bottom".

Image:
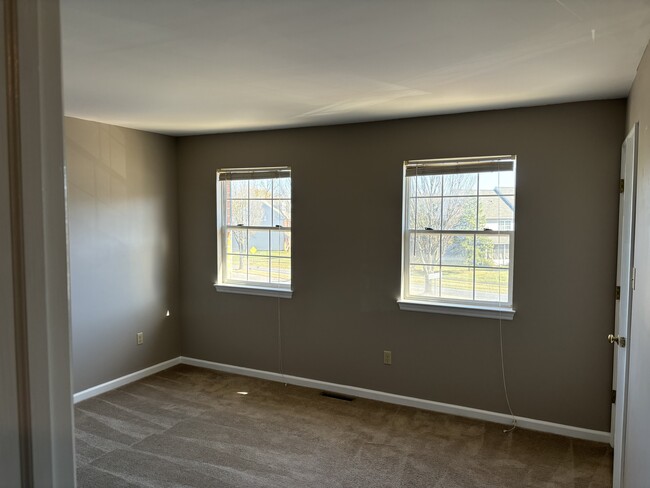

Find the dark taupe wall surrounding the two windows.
[{"left": 177, "top": 100, "right": 626, "bottom": 431}]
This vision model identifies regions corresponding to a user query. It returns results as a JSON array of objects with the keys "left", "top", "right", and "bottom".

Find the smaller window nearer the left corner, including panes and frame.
[{"left": 215, "top": 167, "right": 291, "bottom": 297}]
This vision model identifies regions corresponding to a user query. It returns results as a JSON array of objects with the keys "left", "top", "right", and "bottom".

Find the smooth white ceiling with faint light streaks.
[{"left": 61, "top": 0, "right": 650, "bottom": 135}]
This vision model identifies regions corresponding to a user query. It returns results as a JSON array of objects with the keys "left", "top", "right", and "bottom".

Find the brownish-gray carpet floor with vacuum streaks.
[{"left": 75, "top": 365, "right": 612, "bottom": 488}]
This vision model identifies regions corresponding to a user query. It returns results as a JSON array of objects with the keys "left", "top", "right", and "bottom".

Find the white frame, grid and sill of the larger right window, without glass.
[{"left": 398, "top": 155, "right": 516, "bottom": 320}]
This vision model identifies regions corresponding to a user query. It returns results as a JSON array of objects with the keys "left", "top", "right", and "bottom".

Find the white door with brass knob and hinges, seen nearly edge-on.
[{"left": 608, "top": 123, "right": 639, "bottom": 488}]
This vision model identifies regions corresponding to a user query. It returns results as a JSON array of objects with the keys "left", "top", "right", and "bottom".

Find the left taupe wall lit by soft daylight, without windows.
[{"left": 65, "top": 118, "right": 181, "bottom": 392}]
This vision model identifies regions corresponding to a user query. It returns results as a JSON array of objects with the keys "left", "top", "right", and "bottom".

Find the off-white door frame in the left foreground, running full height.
[{"left": 0, "top": 0, "right": 75, "bottom": 487}]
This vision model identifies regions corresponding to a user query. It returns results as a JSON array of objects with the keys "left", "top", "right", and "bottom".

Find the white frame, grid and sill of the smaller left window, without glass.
[{"left": 214, "top": 166, "right": 293, "bottom": 298}]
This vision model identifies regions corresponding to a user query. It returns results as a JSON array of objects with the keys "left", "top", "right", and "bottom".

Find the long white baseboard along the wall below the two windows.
[{"left": 180, "top": 356, "right": 611, "bottom": 443}]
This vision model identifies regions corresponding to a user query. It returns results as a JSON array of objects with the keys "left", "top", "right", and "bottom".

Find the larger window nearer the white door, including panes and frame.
[{"left": 399, "top": 156, "right": 515, "bottom": 319}]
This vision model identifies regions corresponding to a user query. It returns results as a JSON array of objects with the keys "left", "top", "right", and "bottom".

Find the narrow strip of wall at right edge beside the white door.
[{"left": 624, "top": 44, "right": 650, "bottom": 487}]
